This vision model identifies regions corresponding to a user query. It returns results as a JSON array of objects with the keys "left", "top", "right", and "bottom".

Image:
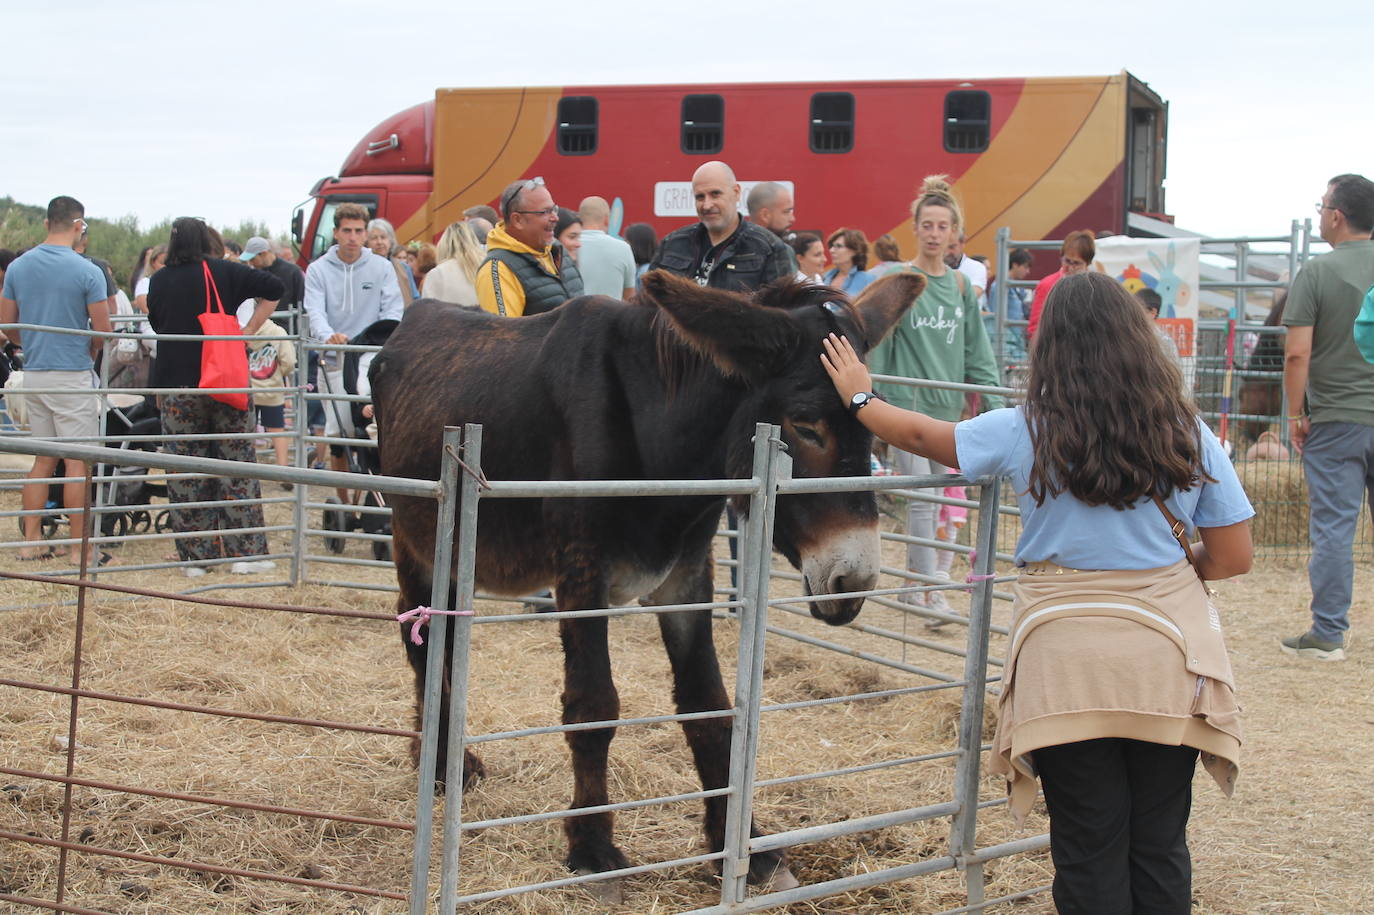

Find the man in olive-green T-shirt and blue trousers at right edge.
[{"left": 1279, "top": 174, "right": 1374, "bottom": 661}]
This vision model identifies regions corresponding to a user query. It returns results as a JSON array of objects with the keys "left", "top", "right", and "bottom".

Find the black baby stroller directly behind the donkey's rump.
[{"left": 320, "top": 319, "right": 400, "bottom": 562}]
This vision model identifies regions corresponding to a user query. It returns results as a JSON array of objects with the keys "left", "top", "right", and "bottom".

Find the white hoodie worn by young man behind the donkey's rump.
[{"left": 305, "top": 245, "right": 404, "bottom": 341}]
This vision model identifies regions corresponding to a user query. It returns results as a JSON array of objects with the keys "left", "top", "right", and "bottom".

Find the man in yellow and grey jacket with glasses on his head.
[{"left": 477, "top": 177, "right": 583, "bottom": 317}]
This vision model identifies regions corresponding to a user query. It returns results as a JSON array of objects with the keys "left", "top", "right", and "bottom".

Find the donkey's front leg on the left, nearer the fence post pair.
[{"left": 555, "top": 577, "right": 629, "bottom": 892}]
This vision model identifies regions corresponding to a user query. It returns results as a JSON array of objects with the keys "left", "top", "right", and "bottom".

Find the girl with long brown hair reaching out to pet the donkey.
[{"left": 822, "top": 273, "right": 1254, "bottom": 915}]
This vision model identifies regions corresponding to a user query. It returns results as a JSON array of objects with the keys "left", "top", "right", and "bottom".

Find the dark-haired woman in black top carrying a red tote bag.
[{"left": 148, "top": 217, "right": 286, "bottom": 577}]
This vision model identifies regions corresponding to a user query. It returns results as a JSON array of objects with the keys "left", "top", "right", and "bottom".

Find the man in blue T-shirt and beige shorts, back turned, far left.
[{"left": 0, "top": 196, "right": 110, "bottom": 562}]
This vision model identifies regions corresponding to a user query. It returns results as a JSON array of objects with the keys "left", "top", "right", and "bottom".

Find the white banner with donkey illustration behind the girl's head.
[{"left": 1092, "top": 235, "right": 1202, "bottom": 357}]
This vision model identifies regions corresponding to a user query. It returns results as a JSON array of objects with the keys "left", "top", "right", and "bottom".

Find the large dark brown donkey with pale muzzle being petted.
[{"left": 370, "top": 271, "right": 925, "bottom": 899}]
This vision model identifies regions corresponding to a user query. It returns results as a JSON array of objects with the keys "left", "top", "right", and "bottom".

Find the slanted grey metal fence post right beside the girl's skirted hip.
[{"left": 949, "top": 477, "right": 1010, "bottom": 905}]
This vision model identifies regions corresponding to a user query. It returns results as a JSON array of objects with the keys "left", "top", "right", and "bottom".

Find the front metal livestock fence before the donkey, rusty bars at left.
[{"left": 0, "top": 414, "right": 1046, "bottom": 912}]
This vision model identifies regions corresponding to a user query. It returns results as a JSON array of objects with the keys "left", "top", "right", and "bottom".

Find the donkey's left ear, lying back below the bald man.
[{"left": 640, "top": 271, "right": 801, "bottom": 381}]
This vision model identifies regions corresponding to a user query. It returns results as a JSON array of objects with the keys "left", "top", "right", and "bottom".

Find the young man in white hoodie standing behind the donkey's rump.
[{"left": 305, "top": 203, "right": 403, "bottom": 491}]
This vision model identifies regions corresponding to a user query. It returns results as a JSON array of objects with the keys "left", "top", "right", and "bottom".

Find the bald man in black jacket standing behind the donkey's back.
[{"left": 649, "top": 162, "right": 794, "bottom": 293}]
